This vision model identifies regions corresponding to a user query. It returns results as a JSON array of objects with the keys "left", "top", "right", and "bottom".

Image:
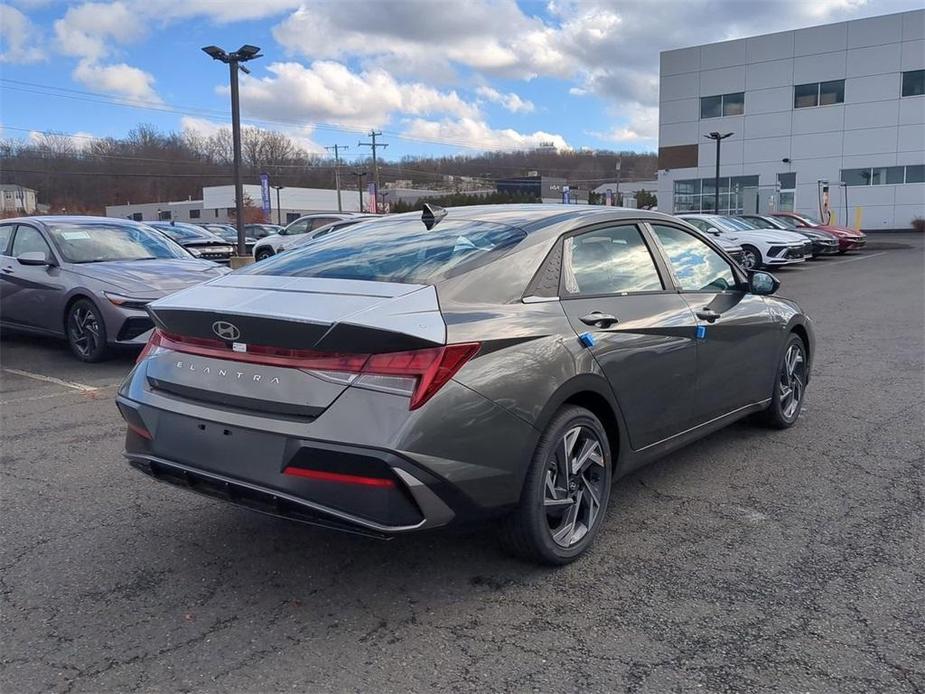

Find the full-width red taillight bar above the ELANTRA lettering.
[{"left": 138, "top": 330, "right": 480, "bottom": 410}]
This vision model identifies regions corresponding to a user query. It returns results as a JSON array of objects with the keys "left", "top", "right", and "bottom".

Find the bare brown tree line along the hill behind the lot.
[{"left": 0, "top": 124, "right": 657, "bottom": 214}]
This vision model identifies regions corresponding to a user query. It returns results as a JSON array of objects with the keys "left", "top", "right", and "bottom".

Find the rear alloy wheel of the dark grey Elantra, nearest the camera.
[{"left": 543, "top": 426, "right": 606, "bottom": 548}]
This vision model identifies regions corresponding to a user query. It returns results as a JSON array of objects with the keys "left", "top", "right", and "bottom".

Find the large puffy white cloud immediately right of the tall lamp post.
[{"left": 238, "top": 61, "right": 478, "bottom": 128}]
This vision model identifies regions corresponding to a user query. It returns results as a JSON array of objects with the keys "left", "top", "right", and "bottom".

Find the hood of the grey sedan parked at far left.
[{"left": 67, "top": 258, "right": 228, "bottom": 298}]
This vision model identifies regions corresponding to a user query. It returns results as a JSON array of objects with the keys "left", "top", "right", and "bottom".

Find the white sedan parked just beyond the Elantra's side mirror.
[{"left": 677, "top": 214, "right": 812, "bottom": 270}]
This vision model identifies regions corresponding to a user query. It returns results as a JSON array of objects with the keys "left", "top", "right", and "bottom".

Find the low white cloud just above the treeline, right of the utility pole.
[{"left": 403, "top": 118, "right": 571, "bottom": 150}]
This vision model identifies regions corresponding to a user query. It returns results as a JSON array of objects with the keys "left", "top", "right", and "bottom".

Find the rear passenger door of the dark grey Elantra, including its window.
[{"left": 560, "top": 223, "right": 696, "bottom": 450}]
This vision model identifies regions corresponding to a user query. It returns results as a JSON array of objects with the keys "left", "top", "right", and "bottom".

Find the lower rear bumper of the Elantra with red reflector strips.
[{"left": 116, "top": 384, "right": 520, "bottom": 538}]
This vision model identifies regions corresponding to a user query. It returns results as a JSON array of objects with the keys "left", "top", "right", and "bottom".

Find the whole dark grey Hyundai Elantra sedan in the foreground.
[{"left": 117, "top": 205, "right": 814, "bottom": 564}]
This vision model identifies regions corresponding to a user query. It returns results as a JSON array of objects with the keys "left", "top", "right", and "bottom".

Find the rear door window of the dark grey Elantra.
[{"left": 562, "top": 225, "right": 663, "bottom": 296}]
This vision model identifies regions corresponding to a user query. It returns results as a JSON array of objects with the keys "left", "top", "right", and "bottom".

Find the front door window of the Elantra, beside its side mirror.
[{"left": 652, "top": 224, "right": 737, "bottom": 292}]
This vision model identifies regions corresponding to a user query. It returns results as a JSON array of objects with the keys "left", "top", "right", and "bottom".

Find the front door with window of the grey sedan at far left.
[{"left": 0, "top": 224, "right": 64, "bottom": 333}]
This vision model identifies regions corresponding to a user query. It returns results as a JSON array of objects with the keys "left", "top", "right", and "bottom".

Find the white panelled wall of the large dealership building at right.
[{"left": 658, "top": 10, "right": 925, "bottom": 229}]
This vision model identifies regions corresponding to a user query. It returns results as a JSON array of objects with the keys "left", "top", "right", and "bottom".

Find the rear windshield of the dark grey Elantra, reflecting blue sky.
[{"left": 245, "top": 217, "right": 526, "bottom": 283}]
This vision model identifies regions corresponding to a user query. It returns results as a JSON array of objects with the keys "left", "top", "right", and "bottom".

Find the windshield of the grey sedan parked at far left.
[{"left": 48, "top": 222, "right": 190, "bottom": 263}]
